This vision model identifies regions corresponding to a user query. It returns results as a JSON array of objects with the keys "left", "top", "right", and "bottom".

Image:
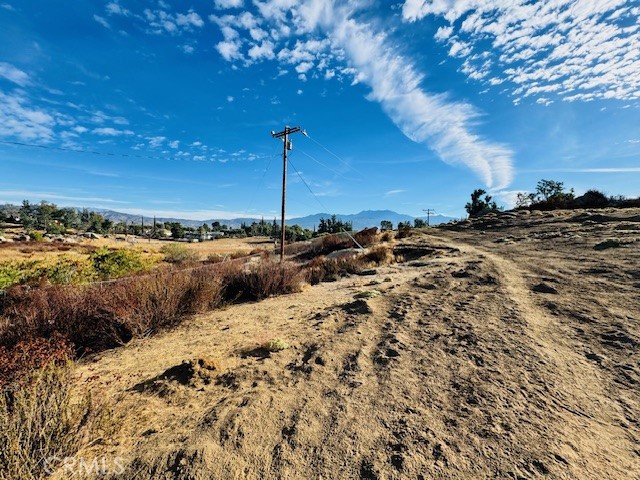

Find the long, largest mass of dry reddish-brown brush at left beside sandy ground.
[{"left": 0, "top": 262, "right": 242, "bottom": 353}]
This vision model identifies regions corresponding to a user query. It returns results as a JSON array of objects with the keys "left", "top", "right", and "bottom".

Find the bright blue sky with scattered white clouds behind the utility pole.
[{"left": 0, "top": 0, "right": 640, "bottom": 219}]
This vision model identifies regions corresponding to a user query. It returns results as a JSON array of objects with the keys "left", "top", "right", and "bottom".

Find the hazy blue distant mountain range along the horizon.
[{"left": 96, "top": 210, "right": 453, "bottom": 230}]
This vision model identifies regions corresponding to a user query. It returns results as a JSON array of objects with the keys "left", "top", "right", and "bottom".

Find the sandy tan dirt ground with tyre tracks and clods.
[{"left": 66, "top": 210, "right": 640, "bottom": 479}]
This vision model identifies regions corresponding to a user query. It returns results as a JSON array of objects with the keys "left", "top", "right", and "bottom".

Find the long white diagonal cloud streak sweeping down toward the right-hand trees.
[{"left": 211, "top": 0, "right": 513, "bottom": 188}]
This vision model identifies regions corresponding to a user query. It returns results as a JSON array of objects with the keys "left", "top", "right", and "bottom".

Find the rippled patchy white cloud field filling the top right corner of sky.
[{"left": 402, "top": 0, "right": 640, "bottom": 105}]
